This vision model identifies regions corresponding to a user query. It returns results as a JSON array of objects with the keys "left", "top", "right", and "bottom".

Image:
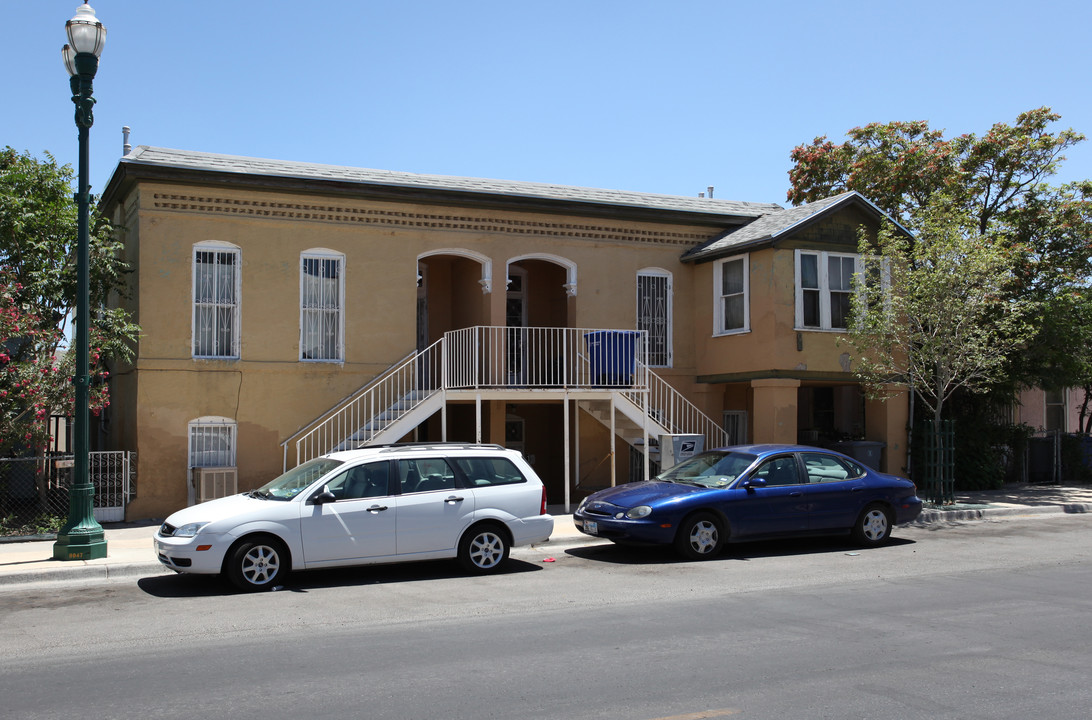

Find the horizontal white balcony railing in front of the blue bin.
[{"left": 446, "top": 326, "right": 645, "bottom": 390}]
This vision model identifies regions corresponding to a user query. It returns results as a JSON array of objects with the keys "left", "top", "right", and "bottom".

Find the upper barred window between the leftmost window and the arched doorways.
[{"left": 299, "top": 253, "right": 345, "bottom": 361}]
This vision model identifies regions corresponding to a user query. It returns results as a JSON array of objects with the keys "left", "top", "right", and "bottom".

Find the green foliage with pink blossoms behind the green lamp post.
[{"left": 0, "top": 147, "right": 139, "bottom": 455}]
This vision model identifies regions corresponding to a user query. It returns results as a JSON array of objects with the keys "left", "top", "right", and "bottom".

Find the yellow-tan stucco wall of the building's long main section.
[{"left": 114, "top": 181, "right": 715, "bottom": 518}]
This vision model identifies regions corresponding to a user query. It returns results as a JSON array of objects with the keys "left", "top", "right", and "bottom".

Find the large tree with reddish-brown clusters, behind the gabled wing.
[{"left": 788, "top": 107, "right": 1092, "bottom": 402}]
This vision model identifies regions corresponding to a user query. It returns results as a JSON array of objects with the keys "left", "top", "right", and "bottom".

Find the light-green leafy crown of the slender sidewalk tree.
[{"left": 846, "top": 202, "right": 1034, "bottom": 432}]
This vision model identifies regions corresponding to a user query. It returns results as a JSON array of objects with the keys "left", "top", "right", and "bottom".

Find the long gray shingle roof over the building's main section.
[{"left": 119, "top": 145, "right": 781, "bottom": 219}]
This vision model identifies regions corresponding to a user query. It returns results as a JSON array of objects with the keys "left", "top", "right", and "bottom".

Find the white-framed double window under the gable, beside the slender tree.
[{"left": 796, "top": 250, "right": 860, "bottom": 330}]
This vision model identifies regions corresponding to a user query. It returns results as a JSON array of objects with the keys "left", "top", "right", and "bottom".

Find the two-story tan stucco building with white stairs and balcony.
[{"left": 102, "top": 146, "right": 907, "bottom": 518}]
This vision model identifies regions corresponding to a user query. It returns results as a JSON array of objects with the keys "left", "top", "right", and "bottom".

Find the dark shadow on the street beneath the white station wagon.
[{"left": 137, "top": 558, "right": 543, "bottom": 599}]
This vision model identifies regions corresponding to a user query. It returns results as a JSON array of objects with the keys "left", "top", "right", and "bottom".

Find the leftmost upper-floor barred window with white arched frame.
[{"left": 193, "top": 246, "right": 239, "bottom": 357}]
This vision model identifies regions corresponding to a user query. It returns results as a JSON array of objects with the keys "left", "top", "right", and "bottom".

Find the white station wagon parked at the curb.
[{"left": 154, "top": 444, "right": 554, "bottom": 590}]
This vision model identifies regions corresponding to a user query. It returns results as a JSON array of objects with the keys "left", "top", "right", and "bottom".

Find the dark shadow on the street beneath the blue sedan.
[{"left": 565, "top": 535, "right": 914, "bottom": 565}]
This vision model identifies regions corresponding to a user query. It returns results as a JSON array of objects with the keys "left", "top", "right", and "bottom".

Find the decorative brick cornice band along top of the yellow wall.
[{"left": 152, "top": 192, "right": 709, "bottom": 247}]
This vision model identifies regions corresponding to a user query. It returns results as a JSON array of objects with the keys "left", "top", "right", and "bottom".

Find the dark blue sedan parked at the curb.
[{"left": 573, "top": 445, "right": 922, "bottom": 559}]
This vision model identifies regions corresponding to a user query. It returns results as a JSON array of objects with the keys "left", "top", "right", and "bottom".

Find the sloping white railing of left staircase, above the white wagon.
[{"left": 282, "top": 340, "right": 443, "bottom": 469}]
